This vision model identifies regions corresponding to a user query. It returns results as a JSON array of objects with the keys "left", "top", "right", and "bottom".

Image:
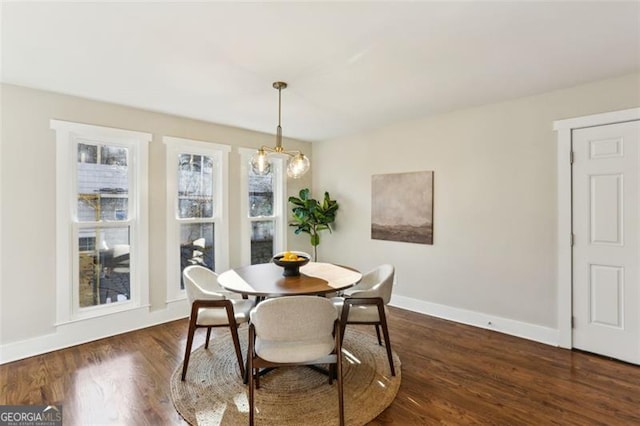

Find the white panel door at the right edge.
[{"left": 572, "top": 121, "right": 640, "bottom": 364}]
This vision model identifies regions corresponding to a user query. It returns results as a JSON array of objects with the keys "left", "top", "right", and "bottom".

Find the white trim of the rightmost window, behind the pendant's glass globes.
[{"left": 238, "top": 148, "right": 288, "bottom": 265}]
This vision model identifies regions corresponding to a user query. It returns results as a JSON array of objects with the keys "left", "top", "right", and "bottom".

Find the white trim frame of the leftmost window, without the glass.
[{"left": 50, "top": 120, "right": 152, "bottom": 325}]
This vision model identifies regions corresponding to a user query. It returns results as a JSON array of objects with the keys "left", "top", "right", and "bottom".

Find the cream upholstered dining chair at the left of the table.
[{"left": 182, "top": 265, "right": 254, "bottom": 380}]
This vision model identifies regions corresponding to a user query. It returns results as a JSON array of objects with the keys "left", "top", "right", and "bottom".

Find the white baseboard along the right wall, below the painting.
[{"left": 390, "top": 295, "right": 560, "bottom": 346}]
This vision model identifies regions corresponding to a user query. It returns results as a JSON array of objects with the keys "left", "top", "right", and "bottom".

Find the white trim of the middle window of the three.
[{"left": 162, "top": 136, "right": 231, "bottom": 303}]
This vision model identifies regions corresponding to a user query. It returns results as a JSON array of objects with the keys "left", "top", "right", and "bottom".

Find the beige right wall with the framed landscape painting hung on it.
[{"left": 313, "top": 74, "right": 640, "bottom": 330}]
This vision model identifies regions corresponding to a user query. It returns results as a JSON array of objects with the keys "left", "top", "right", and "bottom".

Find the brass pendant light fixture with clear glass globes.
[{"left": 251, "top": 81, "right": 311, "bottom": 179}]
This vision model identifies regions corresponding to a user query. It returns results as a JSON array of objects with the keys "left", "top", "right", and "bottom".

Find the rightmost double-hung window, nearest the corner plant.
[{"left": 239, "top": 148, "right": 286, "bottom": 265}]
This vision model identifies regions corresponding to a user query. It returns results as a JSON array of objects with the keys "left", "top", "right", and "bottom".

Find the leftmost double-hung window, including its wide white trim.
[{"left": 51, "top": 120, "right": 151, "bottom": 323}]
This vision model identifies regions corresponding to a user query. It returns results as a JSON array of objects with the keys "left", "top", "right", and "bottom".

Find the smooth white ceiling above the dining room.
[{"left": 1, "top": 1, "right": 640, "bottom": 141}]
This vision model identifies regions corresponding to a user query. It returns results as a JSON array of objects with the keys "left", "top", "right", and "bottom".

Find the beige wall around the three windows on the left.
[{"left": 0, "top": 85, "right": 311, "bottom": 348}]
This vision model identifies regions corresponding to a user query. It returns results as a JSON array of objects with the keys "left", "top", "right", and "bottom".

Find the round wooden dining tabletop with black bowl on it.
[{"left": 218, "top": 262, "right": 362, "bottom": 298}]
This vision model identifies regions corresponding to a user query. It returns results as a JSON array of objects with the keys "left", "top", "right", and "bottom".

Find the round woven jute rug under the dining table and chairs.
[{"left": 171, "top": 327, "right": 401, "bottom": 426}]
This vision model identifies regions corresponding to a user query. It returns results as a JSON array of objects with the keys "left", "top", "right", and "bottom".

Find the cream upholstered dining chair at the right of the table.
[{"left": 331, "top": 264, "right": 396, "bottom": 376}]
